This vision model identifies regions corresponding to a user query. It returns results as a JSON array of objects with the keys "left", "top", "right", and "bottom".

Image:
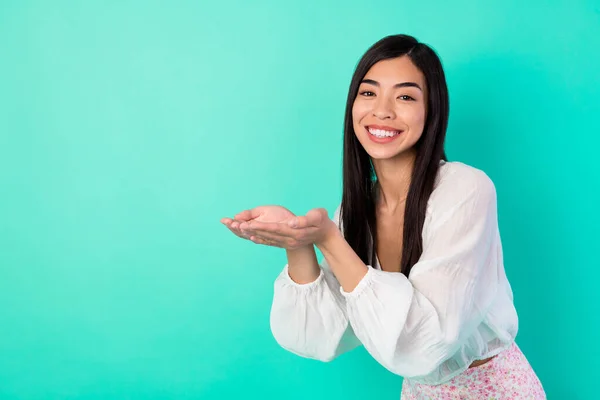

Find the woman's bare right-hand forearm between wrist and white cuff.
[{"left": 316, "top": 229, "right": 368, "bottom": 292}]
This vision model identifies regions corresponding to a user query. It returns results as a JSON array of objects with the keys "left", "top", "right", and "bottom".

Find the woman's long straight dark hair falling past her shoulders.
[{"left": 340, "top": 35, "right": 449, "bottom": 276}]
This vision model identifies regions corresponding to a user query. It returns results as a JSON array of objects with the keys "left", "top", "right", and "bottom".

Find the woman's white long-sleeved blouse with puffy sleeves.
[{"left": 270, "top": 162, "right": 518, "bottom": 385}]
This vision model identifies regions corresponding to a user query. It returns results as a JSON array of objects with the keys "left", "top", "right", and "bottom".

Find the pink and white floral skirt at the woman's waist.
[{"left": 400, "top": 343, "right": 546, "bottom": 400}]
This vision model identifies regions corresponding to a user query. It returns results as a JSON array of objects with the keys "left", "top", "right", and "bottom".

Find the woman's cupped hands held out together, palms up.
[{"left": 222, "top": 206, "right": 337, "bottom": 250}]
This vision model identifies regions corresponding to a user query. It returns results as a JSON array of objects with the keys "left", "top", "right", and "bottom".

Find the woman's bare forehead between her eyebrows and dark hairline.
[{"left": 364, "top": 56, "right": 425, "bottom": 87}]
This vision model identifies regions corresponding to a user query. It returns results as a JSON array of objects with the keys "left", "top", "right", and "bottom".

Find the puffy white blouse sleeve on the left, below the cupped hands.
[{"left": 270, "top": 207, "right": 360, "bottom": 361}]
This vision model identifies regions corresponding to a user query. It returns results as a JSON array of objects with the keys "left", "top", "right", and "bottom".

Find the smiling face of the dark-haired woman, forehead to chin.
[{"left": 352, "top": 56, "right": 427, "bottom": 160}]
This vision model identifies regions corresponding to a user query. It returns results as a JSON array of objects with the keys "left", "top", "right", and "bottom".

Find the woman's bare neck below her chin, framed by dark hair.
[{"left": 373, "top": 150, "right": 416, "bottom": 215}]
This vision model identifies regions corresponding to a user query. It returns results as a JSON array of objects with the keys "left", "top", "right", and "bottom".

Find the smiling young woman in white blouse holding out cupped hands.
[{"left": 222, "top": 35, "right": 546, "bottom": 400}]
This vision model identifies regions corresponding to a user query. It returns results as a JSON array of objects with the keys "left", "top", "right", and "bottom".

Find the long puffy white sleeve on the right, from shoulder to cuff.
[{"left": 340, "top": 171, "right": 501, "bottom": 378}]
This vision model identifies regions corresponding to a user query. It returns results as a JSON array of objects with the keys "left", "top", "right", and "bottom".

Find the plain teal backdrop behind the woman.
[{"left": 0, "top": 0, "right": 600, "bottom": 400}]
